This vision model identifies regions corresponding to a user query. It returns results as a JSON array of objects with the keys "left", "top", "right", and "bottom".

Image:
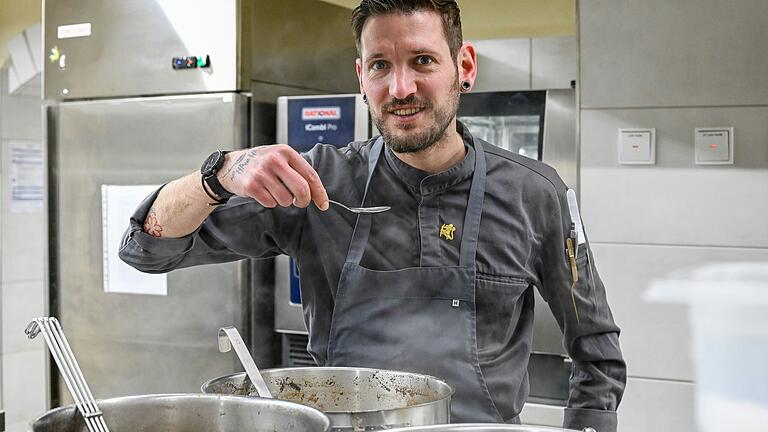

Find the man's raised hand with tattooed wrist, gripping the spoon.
[{"left": 218, "top": 144, "right": 328, "bottom": 210}]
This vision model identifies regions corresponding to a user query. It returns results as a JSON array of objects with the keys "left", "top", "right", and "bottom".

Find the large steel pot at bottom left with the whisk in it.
[{"left": 32, "top": 394, "right": 331, "bottom": 432}]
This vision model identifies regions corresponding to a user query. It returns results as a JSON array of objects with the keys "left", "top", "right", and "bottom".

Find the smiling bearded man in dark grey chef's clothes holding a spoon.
[{"left": 120, "top": 0, "right": 625, "bottom": 432}]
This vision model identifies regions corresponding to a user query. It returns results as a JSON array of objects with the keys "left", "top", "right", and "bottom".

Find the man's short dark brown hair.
[{"left": 352, "top": 0, "right": 464, "bottom": 62}]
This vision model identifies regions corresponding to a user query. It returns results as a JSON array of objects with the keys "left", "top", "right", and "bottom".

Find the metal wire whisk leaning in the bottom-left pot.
[{"left": 24, "top": 317, "right": 109, "bottom": 432}]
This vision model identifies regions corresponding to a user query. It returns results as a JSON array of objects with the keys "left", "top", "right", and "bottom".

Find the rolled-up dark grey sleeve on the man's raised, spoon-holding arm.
[{"left": 119, "top": 188, "right": 305, "bottom": 273}]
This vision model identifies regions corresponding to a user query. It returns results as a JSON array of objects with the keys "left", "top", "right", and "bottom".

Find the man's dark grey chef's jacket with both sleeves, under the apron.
[{"left": 120, "top": 125, "right": 626, "bottom": 432}]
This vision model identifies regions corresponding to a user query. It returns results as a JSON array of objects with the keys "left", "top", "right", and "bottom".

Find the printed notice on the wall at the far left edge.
[{"left": 8, "top": 141, "right": 45, "bottom": 213}]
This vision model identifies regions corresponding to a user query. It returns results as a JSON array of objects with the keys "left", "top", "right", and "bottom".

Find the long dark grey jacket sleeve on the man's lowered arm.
[{"left": 538, "top": 185, "right": 626, "bottom": 432}]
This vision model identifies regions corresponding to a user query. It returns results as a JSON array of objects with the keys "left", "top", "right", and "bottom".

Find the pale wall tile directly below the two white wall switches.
[{"left": 581, "top": 168, "right": 768, "bottom": 248}]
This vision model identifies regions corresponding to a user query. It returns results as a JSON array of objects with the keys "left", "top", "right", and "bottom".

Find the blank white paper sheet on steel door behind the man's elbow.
[{"left": 101, "top": 185, "right": 168, "bottom": 296}]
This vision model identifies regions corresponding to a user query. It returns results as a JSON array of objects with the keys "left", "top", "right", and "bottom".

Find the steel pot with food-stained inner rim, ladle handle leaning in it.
[{"left": 202, "top": 367, "right": 453, "bottom": 432}]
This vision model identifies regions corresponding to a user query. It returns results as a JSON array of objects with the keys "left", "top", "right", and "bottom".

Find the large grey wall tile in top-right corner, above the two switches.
[{"left": 578, "top": 0, "right": 768, "bottom": 108}]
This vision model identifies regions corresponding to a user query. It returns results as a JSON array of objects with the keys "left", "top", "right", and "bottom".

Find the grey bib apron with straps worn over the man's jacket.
[{"left": 328, "top": 138, "right": 504, "bottom": 423}]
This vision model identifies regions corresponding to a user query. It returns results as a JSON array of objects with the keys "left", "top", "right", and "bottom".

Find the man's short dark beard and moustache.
[{"left": 370, "top": 74, "right": 460, "bottom": 153}]
